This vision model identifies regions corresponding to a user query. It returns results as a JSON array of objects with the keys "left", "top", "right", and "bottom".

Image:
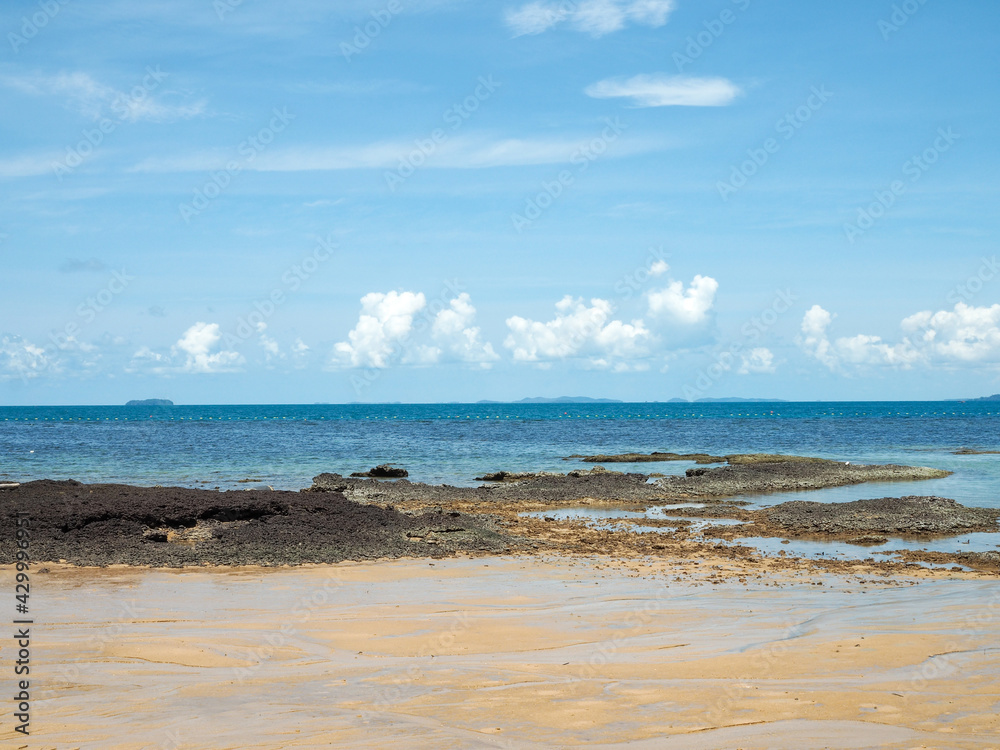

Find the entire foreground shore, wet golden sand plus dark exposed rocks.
[{"left": 0, "top": 464, "right": 1000, "bottom": 750}]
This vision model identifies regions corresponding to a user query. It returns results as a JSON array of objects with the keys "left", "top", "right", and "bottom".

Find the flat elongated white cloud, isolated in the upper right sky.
[{"left": 584, "top": 74, "right": 741, "bottom": 107}]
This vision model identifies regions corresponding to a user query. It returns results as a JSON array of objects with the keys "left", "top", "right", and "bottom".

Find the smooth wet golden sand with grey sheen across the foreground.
[{"left": 0, "top": 556, "right": 1000, "bottom": 749}]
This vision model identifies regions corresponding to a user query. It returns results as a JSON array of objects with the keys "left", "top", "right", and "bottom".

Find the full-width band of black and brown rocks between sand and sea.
[{"left": 0, "top": 454, "right": 1000, "bottom": 580}]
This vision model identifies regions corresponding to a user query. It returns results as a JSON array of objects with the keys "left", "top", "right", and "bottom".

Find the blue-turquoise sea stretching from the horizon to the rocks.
[{"left": 0, "top": 402, "right": 1000, "bottom": 507}]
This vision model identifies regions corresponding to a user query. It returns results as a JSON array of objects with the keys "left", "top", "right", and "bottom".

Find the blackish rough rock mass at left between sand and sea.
[{"left": 0, "top": 480, "right": 510, "bottom": 566}]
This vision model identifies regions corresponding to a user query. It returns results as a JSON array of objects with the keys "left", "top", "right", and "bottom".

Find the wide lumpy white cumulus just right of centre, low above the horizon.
[{"left": 504, "top": 295, "right": 652, "bottom": 366}]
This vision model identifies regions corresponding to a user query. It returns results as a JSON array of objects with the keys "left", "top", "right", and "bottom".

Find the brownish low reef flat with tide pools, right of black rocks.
[{"left": 309, "top": 454, "right": 1000, "bottom": 574}]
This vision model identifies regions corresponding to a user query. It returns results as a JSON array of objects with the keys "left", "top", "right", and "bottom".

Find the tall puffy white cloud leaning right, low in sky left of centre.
[{"left": 332, "top": 291, "right": 426, "bottom": 368}]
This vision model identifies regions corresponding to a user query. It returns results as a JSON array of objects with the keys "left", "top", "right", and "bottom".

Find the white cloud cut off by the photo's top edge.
[{"left": 504, "top": 0, "right": 674, "bottom": 37}]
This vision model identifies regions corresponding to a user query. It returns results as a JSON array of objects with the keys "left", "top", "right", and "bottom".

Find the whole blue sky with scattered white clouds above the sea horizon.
[{"left": 0, "top": 0, "right": 1000, "bottom": 405}]
